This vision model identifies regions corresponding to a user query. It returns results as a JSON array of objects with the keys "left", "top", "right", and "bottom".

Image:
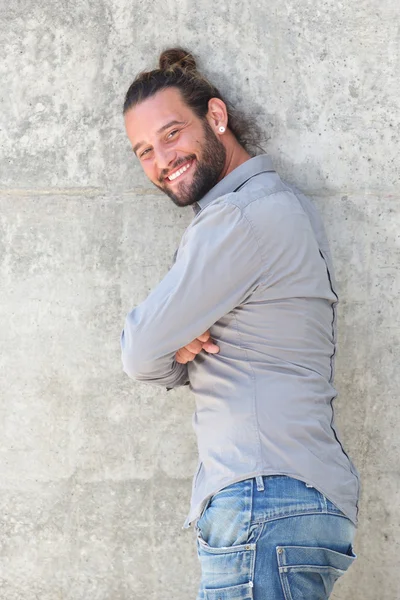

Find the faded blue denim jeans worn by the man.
[{"left": 196, "top": 475, "right": 356, "bottom": 600}]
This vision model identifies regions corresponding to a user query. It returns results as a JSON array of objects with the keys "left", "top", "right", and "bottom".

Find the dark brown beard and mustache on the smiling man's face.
[{"left": 157, "top": 120, "right": 226, "bottom": 207}]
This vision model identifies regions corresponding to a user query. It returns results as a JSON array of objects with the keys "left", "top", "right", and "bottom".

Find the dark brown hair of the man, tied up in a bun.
[{"left": 123, "top": 48, "right": 260, "bottom": 153}]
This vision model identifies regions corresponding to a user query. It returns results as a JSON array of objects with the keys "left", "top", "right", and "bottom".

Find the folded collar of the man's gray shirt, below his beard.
[{"left": 192, "top": 154, "right": 274, "bottom": 214}]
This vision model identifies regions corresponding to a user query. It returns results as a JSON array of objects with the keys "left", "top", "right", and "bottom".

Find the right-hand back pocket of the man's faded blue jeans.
[{"left": 276, "top": 546, "right": 356, "bottom": 600}]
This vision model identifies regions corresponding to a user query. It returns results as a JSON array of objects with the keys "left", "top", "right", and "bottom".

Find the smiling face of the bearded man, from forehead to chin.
[{"left": 125, "top": 88, "right": 226, "bottom": 206}]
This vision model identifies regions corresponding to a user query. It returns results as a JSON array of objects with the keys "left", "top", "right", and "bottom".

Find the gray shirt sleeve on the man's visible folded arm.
[{"left": 121, "top": 201, "right": 262, "bottom": 388}]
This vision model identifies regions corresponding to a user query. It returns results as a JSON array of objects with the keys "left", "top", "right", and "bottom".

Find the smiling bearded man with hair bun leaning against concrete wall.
[{"left": 121, "top": 49, "right": 359, "bottom": 600}]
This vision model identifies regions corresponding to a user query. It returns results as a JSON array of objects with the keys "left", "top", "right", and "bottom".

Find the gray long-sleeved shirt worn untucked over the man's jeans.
[{"left": 121, "top": 155, "right": 359, "bottom": 526}]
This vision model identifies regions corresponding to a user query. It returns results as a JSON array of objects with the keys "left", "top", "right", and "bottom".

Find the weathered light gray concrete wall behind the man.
[{"left": 0, "top": 0, "right": 400, "bottom": 600}]
